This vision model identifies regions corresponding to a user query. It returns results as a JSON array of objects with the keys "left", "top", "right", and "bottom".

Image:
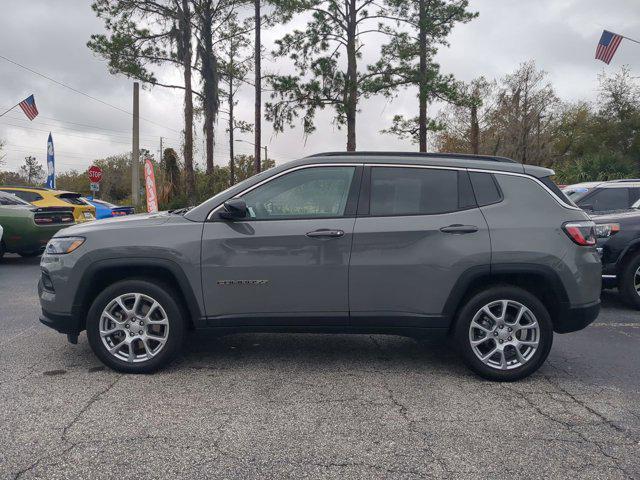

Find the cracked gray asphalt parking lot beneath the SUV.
[{"left": 0, "top": 256, "right": 640, "bottom": 479}]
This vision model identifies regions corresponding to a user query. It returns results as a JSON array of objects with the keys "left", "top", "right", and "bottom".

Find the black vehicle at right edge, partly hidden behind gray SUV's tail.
[{"left": 592, "top": 209, "right": 640, "bottom": 309}]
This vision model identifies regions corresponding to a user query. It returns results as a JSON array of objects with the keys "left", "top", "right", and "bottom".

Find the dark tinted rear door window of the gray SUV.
[{"left": 370, "top": 167, "right": 470, "bottom": 216}]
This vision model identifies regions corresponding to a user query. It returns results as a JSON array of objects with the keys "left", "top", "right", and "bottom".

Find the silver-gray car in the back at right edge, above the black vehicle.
[{"left": 562, "top": 178, "right": 640, "bottom": 213}]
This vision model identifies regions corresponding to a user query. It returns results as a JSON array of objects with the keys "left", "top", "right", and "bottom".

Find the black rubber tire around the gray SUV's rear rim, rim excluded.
[{"left": 454, "top": 285, "right": 553, "bottom": 382}]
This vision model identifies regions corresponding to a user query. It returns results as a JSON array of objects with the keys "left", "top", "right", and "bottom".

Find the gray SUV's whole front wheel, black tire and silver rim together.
[{"left": 87, "top": 280, "right": 184, "bottom": 373}]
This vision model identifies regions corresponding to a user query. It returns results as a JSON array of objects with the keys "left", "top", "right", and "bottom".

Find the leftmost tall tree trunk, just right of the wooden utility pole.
[{"left": 180, "top": 0, "right": 196, "bottom": 205}]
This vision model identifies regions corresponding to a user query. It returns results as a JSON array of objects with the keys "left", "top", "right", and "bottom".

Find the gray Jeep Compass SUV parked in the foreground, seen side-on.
[{"left": 39, "top": 152, "right": 601, "bottom": 380}]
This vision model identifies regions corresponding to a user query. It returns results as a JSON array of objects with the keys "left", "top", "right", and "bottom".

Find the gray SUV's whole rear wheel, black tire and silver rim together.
[{"left": 455, "top": 286, "right": 553, "bottom": 381}]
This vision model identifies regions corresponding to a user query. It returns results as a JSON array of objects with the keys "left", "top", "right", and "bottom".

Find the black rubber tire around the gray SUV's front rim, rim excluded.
[{"left": 87, "top": 279, "right": 185, "bottom": 373}]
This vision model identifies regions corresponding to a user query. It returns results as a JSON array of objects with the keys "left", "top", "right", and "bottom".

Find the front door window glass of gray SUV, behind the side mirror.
[{"left": 242, "top": 166, "right": 356, "bottom": 220}]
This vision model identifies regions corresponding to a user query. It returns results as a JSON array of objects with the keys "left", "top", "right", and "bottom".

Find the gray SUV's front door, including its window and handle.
[{"left": 202, "top": 165, "right": 361, "bottom": 326}]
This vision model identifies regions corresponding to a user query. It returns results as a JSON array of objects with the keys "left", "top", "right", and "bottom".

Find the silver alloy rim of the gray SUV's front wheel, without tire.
[{"left": 99, "top": 293, "right": 169, "bottom": 363}]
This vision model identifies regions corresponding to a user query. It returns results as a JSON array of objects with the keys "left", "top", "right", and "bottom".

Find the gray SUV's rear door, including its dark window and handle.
[{"left": 349, "top": 165, "right": 491, "bottom": 327}]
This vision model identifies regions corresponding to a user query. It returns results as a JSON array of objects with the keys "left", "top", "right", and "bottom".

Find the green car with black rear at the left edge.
[{"left": 0, "top": 192, "right": 74, "bottom": 258}]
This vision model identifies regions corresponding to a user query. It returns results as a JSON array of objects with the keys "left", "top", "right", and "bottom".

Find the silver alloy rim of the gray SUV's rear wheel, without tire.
[{"left": 469, "top": 300, "right": 540, "bottom": 370}]
